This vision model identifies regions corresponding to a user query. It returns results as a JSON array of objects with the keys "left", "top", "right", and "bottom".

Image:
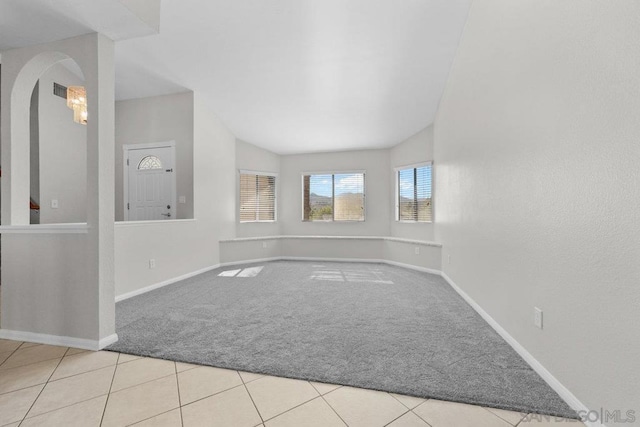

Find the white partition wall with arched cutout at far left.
[{"left": 0, "top": 34, "right": 115, "bottom": 349}]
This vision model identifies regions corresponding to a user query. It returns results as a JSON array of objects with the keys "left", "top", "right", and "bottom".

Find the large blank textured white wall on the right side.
[{"left": 434, "top": 0, "right": 640, "bottom": 422}]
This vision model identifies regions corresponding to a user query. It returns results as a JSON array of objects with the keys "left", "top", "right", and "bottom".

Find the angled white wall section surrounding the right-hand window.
[{"left": 389, "top": 126, "right": 437, "bottom": 241}]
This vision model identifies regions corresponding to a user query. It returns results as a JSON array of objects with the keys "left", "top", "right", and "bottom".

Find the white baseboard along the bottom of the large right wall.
[{"left": 440, "top": 272, "right": 603, "bottom": 427}]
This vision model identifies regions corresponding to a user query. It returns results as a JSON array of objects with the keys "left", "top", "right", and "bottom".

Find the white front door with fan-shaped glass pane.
[{"left": 125, "top": 144, "right": 176, "bottom": 221}]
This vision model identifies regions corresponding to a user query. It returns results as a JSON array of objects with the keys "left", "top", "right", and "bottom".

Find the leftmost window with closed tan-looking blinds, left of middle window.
[{"left": 240, "top": 171, "right": 276, "bottom": 222}]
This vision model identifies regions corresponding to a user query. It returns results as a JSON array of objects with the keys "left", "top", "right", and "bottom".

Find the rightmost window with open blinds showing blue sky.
[{"left": 396, "top": 163, "right": 433, "bottom": 222}]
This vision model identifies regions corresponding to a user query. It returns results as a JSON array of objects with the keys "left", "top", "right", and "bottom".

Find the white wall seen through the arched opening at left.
[{"left": 38, "top": 64, "right": 86, "bottom": 224}]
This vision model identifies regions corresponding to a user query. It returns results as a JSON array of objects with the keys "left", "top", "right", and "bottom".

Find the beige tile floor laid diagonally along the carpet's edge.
[{"left": 0, "top": 340, "right": 582, "bottom": 427}]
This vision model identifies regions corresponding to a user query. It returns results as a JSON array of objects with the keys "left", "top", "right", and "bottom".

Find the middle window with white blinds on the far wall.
[{"left": 302, "top": 172, "right": 364, "bottom": 221}]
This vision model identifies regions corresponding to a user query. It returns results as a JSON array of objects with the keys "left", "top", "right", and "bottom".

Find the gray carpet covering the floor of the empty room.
[{"left": 108, "top": 261, "right": 576, "bottom": 418}]
